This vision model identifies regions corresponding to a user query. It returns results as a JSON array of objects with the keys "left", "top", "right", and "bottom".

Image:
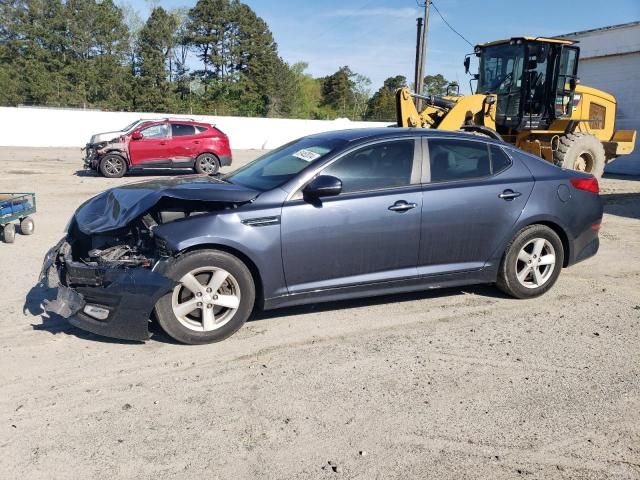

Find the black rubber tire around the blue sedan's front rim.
[{"left": 155, "top": 250, "right": 255, "bottom": 345}]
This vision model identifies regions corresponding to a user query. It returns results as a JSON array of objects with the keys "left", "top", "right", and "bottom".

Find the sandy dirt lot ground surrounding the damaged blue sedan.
[{"left": 0, "top": 148, "right": 640, "bottom": 480}]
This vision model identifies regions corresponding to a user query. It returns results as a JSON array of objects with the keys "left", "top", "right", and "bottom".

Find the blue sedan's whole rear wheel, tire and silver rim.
[{"left": 497, "top": 225, "right": 564, "bottom": 298}]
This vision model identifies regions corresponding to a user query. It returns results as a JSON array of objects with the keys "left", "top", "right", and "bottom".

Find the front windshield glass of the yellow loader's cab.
[{"left": 478, "top": 44, "right": 524, "bottom": 94}]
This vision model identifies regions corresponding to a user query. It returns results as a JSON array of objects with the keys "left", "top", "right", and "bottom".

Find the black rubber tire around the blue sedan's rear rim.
[{"left": 496, "top": 225, "right": 564, "bottom": 298}]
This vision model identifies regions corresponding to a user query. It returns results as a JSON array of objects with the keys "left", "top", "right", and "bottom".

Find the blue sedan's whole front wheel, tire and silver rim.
[{"left": 155, "top": 250, "right": 255, "bottom": 345}]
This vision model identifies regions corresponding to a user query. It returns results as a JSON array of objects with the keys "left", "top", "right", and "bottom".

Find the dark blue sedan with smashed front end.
[{"left": 42, "top": 128, "right": 603, "bottom": 344}]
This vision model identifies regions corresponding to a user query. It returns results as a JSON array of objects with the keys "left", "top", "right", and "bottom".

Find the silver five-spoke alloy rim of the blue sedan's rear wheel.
[{"left": 516, "top": 238, "right": 556, "bottom": 288}]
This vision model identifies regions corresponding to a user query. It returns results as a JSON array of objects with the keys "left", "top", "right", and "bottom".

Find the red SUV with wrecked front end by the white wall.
[{"left": 86, "top": 120, "right": 231, "bottom": 178}]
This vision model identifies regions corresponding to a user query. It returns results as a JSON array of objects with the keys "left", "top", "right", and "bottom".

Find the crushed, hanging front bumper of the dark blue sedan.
[{"left": 40, "top": 239, "right": 176, "bottom": 341}]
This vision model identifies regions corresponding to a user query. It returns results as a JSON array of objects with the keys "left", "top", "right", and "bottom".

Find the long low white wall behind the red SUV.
[{"left": 0, "top": 107, "right": 389, "bottom": 149}]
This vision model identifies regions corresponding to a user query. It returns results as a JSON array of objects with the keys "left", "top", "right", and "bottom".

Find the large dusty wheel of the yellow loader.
[{"left": 553, "top": 133, "right": 606, "bottom": 178}]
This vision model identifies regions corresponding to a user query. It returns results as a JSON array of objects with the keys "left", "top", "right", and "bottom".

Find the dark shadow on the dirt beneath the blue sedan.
[{"left": 22, "top": 283, "right": 511, "bottom": 345}]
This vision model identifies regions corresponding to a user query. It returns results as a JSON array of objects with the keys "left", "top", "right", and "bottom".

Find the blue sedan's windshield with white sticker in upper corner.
[{"left": 223, "top": 137, "right": 346, "bottom": 191}]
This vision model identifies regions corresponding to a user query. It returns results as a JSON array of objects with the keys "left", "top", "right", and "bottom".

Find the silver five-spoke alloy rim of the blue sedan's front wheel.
[{"left": 171, "top": 267, "right": 240, "bottom": 332}]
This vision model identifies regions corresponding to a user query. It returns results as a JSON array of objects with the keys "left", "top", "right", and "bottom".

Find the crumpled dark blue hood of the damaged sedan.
[{"left": 75, "top": 175, "right": 260, "bottom": 235}]
